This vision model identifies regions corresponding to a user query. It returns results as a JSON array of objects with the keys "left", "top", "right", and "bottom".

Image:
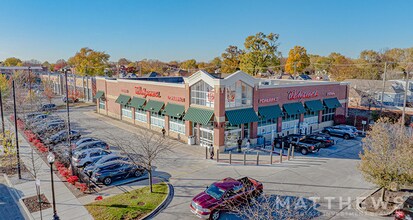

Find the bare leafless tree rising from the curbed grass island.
[{"left": 108, "top": 130, "right": 175, "bottom": 192}]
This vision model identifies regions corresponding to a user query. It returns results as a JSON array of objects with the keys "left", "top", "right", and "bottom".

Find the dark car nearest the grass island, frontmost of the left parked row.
[{"left": 91, "top": 160, "right": 145, "bottom": 185}]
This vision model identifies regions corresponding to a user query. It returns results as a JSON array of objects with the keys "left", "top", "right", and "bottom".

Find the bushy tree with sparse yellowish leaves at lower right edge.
[{"left": 358, "top": 118, "right": 413, "bottom": 201}]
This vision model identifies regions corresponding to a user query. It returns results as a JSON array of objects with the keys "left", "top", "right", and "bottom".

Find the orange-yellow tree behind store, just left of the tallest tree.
[{"left": 221, "top": 45, "right": 242, "bottom": 73}]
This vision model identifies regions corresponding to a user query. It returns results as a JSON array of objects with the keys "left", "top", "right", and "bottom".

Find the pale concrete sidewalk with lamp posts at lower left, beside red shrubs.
[{"left": 5, "top": 120, "right": 93, "bottom": 220}]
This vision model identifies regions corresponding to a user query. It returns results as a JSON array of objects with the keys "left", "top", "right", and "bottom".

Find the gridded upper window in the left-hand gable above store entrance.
[{"left": 191, "top": 80, "right": 215, "bottom": 107}]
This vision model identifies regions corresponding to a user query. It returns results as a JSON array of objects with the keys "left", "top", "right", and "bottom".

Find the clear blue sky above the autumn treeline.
[{"left": 0, "top": 0, "right": 413, "bottom": 62}]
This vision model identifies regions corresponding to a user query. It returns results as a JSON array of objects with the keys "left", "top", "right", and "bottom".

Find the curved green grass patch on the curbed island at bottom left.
[{"left": 86, "top": 183, "right": 168, "bottom": 220}]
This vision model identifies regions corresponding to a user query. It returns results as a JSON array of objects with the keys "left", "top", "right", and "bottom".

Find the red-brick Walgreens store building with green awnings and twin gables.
[{"left": 95, "top": 71, "right": 348, "bottom": 151}]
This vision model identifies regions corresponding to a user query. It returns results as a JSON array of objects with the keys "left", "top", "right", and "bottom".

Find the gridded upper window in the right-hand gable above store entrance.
[{"left": 225, "top": 81, "right": 252, "bottom": 108}]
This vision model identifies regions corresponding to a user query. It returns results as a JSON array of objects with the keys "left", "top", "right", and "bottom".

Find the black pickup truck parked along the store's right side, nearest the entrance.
[{"left": 278, "top": 134, "right": 323, "bottom": 155}]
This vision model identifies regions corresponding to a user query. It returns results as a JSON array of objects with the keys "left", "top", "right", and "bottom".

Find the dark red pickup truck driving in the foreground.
[{"left": 190, "top": 177, "right": 263, "bottom": 220}]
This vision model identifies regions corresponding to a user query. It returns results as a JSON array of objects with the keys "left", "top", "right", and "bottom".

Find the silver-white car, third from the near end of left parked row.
[{"left": 72, "top": 148, "right": 112, "bottom": 167}]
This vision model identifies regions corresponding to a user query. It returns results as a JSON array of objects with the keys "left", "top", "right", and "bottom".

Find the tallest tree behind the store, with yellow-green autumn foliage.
[{"left": 240, "top": 32, "right": 280, "bottom": 76}]
